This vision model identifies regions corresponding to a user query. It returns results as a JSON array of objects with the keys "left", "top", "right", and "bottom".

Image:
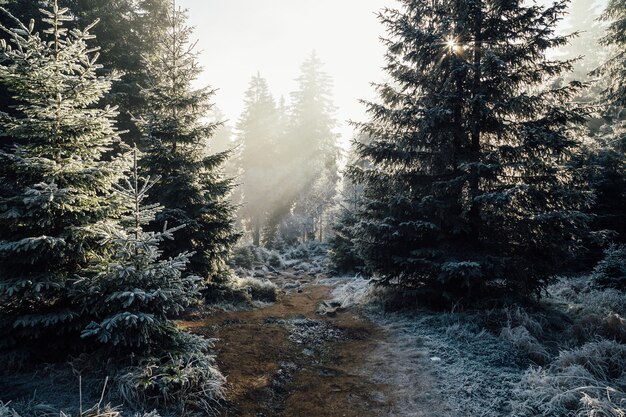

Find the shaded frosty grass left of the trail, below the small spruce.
[{"left": 0, "top": 334, "right": 226, "bottom": 417}]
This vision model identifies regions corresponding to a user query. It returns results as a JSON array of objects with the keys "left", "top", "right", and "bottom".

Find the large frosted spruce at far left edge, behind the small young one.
[{"left": 0, "top": 2, "right": 125, "bottom": 349}]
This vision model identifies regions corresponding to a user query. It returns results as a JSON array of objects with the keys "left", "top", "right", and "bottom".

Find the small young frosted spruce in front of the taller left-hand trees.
[{"left": 79, "top": 150, "right": 200, "bottom": 355}]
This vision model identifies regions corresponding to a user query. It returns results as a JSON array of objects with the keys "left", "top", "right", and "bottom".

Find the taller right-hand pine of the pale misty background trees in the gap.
[{"left": 283, "top": 52, "right": 339, "bottom": 240}]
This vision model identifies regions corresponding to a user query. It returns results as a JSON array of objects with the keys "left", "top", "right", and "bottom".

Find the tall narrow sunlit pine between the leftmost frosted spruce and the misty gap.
[{"left": 140, "top": 2, "right": 239, "bottom": 281}]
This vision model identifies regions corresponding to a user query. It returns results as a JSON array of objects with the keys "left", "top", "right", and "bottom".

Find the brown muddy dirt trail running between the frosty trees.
[{"left": 181, "top": 276, "right": 391, "bottom": 417}]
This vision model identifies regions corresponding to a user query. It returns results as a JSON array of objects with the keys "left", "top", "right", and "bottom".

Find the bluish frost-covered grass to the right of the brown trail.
[{"left": 323, "top": 276, "right": 626, "bottom": 417}]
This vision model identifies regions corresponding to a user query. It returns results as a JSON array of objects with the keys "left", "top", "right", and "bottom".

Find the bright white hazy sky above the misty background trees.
[{"left": 177, "top": 0, "right": 396, "bottom": 146}]
